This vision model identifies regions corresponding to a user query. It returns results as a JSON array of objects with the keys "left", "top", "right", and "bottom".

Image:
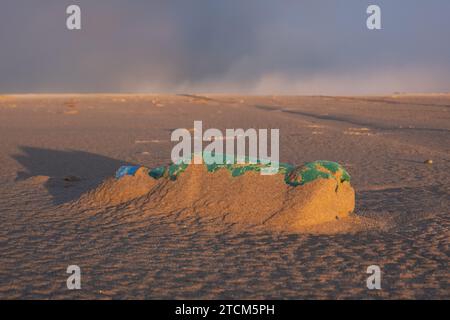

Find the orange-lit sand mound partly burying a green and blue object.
[{"left": 79, "top": 161, "right": 355, "bottom": 231}]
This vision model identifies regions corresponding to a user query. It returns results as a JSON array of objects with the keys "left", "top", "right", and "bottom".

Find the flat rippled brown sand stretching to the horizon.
[{"left": 0, "top": 94, "right": 450, "bottom": 299}]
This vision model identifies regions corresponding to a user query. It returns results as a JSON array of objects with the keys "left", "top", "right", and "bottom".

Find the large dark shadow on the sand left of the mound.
[{"left": 12, "top": 146, "right": 131, "bottom": 204}]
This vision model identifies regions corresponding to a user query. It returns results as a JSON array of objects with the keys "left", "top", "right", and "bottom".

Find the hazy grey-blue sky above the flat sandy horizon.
[{"left": 0, "top": 0, "right": 450, "bottom": 94}]
